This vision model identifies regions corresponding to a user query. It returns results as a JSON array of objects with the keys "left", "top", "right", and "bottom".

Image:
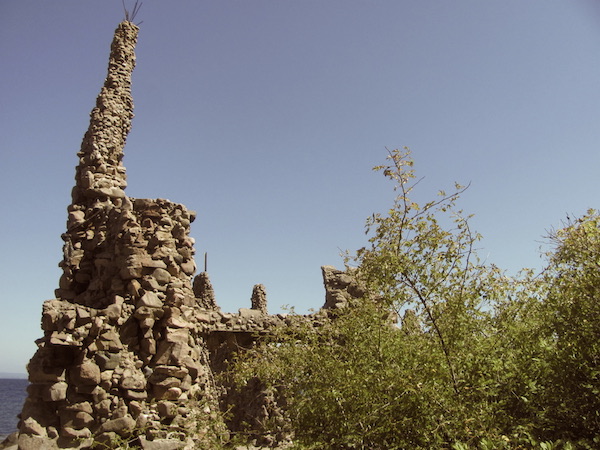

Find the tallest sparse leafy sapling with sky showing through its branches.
[{"left": 356, "top": 149, "right": 495, "bottom": 395}]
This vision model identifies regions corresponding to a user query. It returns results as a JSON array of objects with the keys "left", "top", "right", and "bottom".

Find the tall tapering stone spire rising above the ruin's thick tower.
[{"left": 56, "top": 21, "right": 139, "bottom": 307}]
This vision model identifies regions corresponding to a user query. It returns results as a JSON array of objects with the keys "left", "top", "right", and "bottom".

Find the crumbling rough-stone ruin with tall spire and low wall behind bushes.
[{"left": 0, "top": 21, "right": 364, "bottom": 450}]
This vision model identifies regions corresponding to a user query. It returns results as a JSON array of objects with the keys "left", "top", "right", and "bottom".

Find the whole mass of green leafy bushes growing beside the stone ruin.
[{"left": 233, "top": 149, "right": 600, "bottom": 450}]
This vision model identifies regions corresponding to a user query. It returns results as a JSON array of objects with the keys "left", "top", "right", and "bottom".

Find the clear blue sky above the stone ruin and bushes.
[{"left": 0, "top": 0, "right": 600, "bottom": 372}]
